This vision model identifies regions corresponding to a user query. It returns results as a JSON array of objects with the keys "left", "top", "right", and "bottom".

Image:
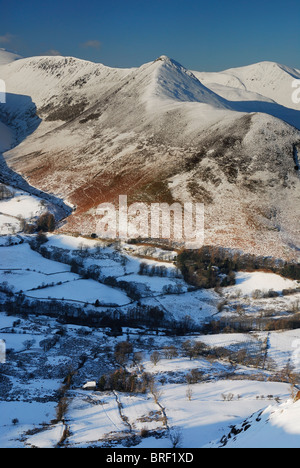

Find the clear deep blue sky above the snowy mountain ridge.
[{"left": 0, "top": 0, "right": 300, "bottom": 71}]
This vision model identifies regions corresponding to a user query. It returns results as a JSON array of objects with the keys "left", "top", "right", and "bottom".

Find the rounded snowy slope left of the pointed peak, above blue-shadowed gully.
[{"left": 0, "top": 57, "right": 130, "bottom": 142}]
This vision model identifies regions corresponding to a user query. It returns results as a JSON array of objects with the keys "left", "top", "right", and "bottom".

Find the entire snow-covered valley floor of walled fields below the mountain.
[{"left": 0, "top": 235, "right": 300, "bottom": 448}]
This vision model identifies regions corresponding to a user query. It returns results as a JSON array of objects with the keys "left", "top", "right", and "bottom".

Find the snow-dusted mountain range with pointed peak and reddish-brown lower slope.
[{"left": 0, "top": 54, "right": 300, "bottom": 257}]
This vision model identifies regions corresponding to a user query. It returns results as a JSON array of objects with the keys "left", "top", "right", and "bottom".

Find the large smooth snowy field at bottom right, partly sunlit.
[{"left": 162, "top": 381, "right": 289, "bottom": 448}]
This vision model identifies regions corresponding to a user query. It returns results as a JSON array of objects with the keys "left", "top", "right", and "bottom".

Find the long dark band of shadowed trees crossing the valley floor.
[{"left": 0, "top": 282, "right": 300, "bottom": 334}]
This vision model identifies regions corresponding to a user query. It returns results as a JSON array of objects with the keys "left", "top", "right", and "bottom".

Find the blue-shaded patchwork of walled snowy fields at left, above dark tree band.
[{"left": 0, "top": 236, "right": 217, "bottom": 322}]
